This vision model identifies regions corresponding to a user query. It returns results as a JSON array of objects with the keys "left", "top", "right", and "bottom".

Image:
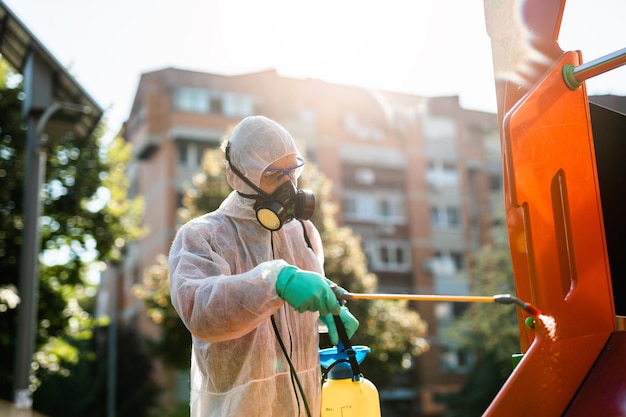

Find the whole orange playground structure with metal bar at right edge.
[{"left": 484, "top": 0, "right": 626, "bottom": 417}]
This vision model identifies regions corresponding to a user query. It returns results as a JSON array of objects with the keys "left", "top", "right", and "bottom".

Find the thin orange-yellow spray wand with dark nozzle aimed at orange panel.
[{"left": 336, "top": 292, "right": 541, "bottom": 318}]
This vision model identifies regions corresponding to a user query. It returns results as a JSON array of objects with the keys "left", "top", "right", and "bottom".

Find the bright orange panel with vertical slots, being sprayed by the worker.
[{"left": 486, "top": 52, "right": 615, "bottom": 416}]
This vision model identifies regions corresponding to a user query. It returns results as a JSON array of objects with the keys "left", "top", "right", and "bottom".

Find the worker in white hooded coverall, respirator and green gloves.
[{"left": 169, "top": 116, "right": 358, "bottom": 417}]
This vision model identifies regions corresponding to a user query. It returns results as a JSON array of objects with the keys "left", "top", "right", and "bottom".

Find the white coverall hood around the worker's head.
[{"left": 220, "top": 116, "right": 301, "bottom": 218}]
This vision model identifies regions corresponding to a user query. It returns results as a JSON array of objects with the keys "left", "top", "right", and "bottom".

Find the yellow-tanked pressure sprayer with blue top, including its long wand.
[{"left": 319, "top": 289, "right": 541, "bottom": 417}]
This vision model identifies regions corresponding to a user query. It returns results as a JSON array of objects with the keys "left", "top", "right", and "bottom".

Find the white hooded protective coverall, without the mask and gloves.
[{"left": 169, "top": 116, "right": 324, "bottom": 417}]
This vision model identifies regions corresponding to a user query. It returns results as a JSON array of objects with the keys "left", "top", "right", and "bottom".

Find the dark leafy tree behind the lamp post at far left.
[{"left": 0, "top": 60, "right": 143, "bottom": 406}]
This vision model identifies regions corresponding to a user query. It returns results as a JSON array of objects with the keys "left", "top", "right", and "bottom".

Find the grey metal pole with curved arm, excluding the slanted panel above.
[{"left": 14, "top": 103, "right": 91, "bottom": 409}]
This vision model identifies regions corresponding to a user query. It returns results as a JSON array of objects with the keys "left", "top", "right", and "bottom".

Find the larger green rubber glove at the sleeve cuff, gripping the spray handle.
[{"left": 276, "top": 265, "right": 340, "bottom": 316}]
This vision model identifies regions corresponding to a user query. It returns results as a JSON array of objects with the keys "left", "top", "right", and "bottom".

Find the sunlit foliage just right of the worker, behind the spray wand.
[{"left": 298, "top": 160, "right": 428, "bottom": 389}]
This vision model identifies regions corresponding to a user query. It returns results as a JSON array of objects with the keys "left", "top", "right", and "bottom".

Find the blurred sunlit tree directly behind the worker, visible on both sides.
[{"left": 135, "top": 143, "right": 428, "bottom": 386}]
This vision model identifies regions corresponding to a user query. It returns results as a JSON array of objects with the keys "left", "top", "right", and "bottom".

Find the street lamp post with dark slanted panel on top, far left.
[{"left": 0, "top": 4, "right": 103, "bottom": 408}]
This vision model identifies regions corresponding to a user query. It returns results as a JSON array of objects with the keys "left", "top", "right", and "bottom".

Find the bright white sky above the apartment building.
[{"left": 4, "top": 0, "right": 626, "bottom": 141}]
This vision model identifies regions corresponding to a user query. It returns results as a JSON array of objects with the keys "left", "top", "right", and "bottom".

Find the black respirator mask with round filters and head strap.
[{"left": 226, "top": 143, "right": 315, "bottom": 232}]
